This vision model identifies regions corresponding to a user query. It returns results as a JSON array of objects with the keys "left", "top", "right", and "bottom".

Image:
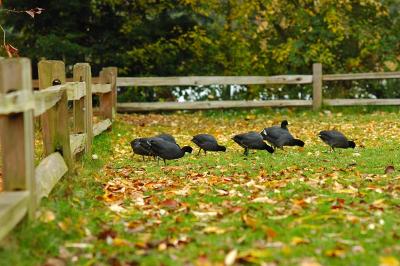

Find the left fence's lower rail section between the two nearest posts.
[{"left": 35, "top": 152, "right": 68, "bottom": 203}]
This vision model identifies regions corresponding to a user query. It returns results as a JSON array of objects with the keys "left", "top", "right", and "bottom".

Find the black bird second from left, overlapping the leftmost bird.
[{"left": 147, "top": 138, "right": 193, "bottom": 165}]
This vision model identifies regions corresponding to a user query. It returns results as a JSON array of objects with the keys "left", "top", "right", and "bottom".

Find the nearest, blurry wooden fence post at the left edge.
[{"left": 0, "top": 58, "right": 36, "bottom": 218}]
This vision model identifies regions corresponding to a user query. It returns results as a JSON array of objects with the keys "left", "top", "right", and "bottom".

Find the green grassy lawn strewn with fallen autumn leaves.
[{"left": 0, "top": 108, "right": 400, "bottom": 266}]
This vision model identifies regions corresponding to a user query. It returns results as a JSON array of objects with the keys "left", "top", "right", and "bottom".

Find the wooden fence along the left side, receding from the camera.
[{"left": 0, "top": 58, "right": 117, "bottom": 239}]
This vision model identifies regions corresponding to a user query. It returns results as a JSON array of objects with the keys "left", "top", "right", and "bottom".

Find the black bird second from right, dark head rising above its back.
[{"left": 261, "top": 120, "right": 304, "bottom": 149}]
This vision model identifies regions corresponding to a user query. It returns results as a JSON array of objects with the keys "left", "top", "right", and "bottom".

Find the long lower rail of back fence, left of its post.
[{"left": 118, "top": 100, "right": 312, "bottom": 112}]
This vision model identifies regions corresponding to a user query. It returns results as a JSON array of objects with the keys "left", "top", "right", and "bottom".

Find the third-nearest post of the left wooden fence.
[{"left": 73, "top": 63, "right": 93, "bottom": 155}]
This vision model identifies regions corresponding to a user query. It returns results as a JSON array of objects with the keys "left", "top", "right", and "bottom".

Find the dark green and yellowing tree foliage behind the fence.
[{"left": 1, "top": 0, "right": 400, "bottom": 100}]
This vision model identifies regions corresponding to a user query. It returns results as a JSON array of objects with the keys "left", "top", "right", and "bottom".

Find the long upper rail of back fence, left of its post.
[{"left": 117, "top": 75, "right": 312, "bottom": 87}]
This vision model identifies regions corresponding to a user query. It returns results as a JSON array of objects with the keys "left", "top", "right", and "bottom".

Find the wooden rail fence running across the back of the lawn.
[{"left": 117, "top": 63, "right": 400, "bottom": 112}]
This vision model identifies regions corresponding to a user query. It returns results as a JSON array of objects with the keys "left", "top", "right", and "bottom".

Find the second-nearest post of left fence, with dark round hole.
[{"left": 38, "top": 60, "right": 74, "bottom": 173}]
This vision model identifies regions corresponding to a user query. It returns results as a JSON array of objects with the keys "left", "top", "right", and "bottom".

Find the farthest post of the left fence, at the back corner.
[{"left": 99, "top": 67, "right": 118, "bottom": 121}]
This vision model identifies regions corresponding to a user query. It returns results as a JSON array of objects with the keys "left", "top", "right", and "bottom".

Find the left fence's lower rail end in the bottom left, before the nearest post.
[{"left": 0, "top": 191, "right": 30, "bottom": 239}]
